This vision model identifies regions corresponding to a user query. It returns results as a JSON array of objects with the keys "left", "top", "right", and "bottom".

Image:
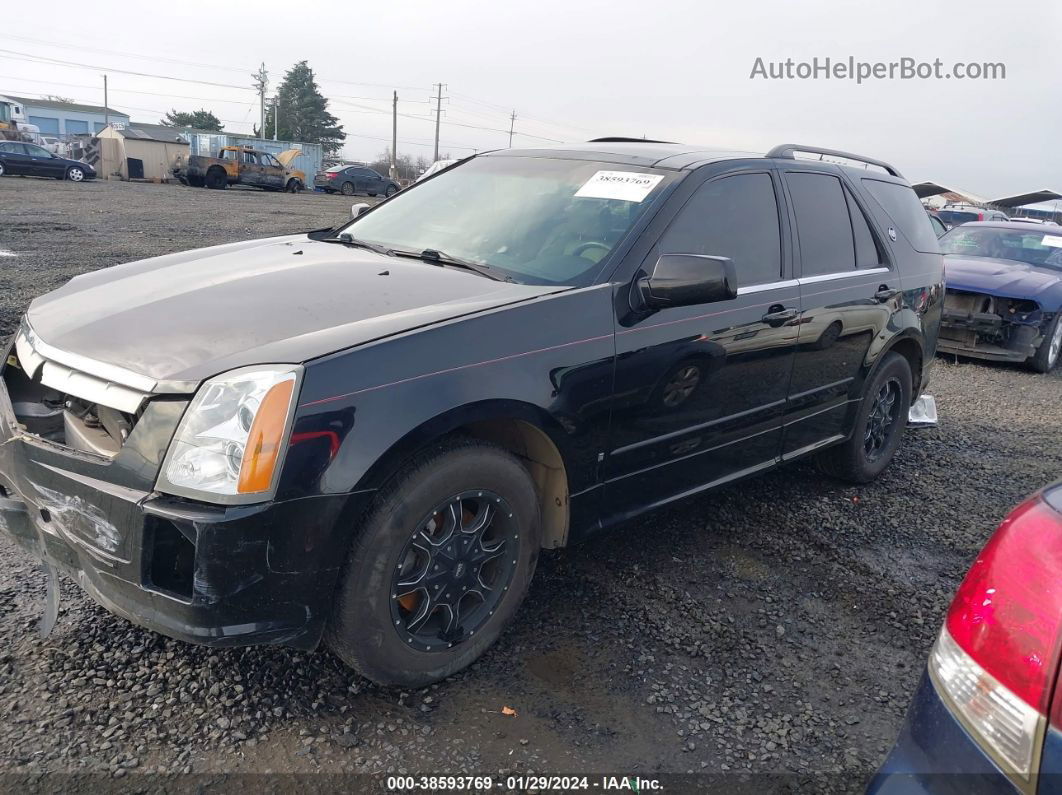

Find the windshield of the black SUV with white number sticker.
[{"left": 344, "top": 156, "right": 668, "bottom": 286}]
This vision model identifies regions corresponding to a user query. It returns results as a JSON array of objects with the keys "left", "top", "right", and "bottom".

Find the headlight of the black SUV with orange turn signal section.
[{"left": 156, "top": 364, "right": 303, "bottom": 504}]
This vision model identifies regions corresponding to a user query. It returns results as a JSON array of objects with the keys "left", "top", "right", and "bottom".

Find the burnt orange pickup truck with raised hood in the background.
[{"left": 173, "top": 146, "right": 306, "bottom": 193}]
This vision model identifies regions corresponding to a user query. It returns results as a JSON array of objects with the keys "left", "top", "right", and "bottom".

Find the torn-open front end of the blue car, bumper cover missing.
[{"left": 937, "top": 290, "right": 1054, "bottom": 362}]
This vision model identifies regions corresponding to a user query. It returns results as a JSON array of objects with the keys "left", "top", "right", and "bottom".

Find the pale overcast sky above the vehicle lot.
[{"left": 0, "top": 0, "right": 1062, "bottom": 197}]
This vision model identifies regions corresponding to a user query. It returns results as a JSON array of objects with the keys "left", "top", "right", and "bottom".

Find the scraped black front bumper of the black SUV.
[{"left": 0, "top": 369, "right": 357, "bottom": 649}]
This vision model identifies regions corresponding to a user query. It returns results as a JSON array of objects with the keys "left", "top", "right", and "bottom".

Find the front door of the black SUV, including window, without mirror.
[{"left": 603, "top": 167, "right": 800, "bottom": 521}]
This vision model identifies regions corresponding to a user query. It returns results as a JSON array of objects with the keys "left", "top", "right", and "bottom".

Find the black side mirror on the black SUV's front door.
[{"left": 637, "top": 254, "right": 737, "bottom": 309}]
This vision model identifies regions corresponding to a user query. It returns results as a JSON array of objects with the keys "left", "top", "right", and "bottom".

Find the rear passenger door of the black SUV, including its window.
[{"left": 783, "top": 167, "right": 900, "bottom": 457}]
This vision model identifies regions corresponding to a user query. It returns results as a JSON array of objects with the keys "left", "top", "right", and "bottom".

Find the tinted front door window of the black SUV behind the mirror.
[{"left": 660, "top": 174, "right": 782, "bottom": 287}]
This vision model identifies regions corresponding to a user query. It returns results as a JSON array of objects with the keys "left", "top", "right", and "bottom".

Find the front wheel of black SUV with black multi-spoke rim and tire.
[{"left": 326, "top": 439, "right": 541, "bottom": 687}]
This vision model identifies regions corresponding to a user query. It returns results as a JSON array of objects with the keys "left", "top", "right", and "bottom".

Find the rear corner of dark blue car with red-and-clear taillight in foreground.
[{"left": 868, "top": 483, "right": 1062, "bottom": 795}]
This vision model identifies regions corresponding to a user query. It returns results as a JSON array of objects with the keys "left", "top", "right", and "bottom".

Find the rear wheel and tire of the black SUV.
[{"left": 818, "top": 352, "right": 912, "bottom": 483}]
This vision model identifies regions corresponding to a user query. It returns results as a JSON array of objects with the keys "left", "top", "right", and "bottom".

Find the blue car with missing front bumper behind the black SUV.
[{"left": 937, "top": 222, "right": 1062, "bottom": 373}]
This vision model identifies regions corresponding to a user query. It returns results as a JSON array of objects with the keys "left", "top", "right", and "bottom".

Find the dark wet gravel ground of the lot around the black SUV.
[{"left": 0, "top": 178, "right": 1062, "bottom": 791}]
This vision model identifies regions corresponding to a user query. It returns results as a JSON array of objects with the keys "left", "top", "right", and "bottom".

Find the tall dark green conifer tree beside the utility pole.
[{"left": 255, "top": 61, "right": 346, "bottom": 155}]
